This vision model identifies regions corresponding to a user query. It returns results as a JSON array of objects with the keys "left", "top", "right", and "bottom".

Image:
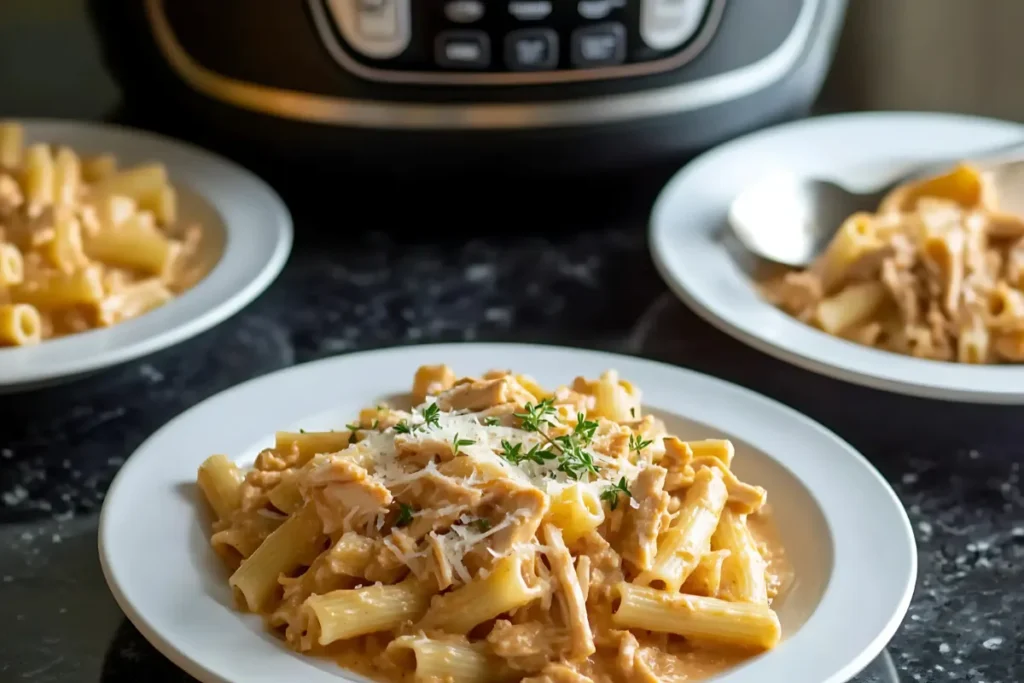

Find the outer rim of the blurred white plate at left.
[{"left": 0, "top": 117, "right": 294, "bottom": 393}]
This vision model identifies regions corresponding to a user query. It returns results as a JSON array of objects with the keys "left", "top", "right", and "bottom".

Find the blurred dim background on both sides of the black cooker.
[{"left": 6, "top": 0, "right": 1024, "bottom": 136}]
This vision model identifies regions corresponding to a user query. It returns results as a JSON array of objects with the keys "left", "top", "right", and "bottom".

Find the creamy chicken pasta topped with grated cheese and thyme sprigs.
[{"left": 198, "top": 366, "right": 788, "bottom": 683}]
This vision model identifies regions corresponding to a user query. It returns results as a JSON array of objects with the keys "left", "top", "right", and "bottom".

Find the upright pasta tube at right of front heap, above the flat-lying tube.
[{"left": 711, "top": 508, "right": 768, "bottom": 605}]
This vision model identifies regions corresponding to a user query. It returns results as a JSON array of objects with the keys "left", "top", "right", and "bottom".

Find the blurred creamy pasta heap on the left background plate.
[{"left": 0, "top": 122, "right": 200, "bottom": 347}]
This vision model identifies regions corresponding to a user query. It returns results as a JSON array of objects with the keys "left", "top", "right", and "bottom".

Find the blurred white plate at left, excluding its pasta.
[{"left": 0, "top": 119, "right": 292, "bottom": 392}]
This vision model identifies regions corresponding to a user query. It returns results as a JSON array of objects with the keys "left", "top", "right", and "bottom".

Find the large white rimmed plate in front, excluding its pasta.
[{"left": 99, "top": 344, "right": 916, "bottom": 683}]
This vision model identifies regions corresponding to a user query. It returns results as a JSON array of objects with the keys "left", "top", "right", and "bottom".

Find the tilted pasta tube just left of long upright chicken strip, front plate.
[{"left": 417, "top": 553, "right": 543, "bottom": 635}]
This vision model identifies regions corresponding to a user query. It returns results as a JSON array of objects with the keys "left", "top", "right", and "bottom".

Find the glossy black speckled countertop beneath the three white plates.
[{"left": 0, "top": 160, "right": 1024, "bottom": 683}]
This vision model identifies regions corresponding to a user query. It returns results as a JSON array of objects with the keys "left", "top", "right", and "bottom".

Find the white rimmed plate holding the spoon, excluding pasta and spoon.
[{"left": 650, "top": 113, "right": 1024, "bottom": 403}]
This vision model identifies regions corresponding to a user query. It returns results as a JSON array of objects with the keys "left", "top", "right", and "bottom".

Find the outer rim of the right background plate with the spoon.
[{"left": 647, "top": 112, "right": 1024, "bottom": 404}]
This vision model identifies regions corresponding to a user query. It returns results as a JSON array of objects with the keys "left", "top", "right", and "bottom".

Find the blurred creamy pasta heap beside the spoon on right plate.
[{"left": 765, "top": 164, "right": 1024, "bottom": 364}]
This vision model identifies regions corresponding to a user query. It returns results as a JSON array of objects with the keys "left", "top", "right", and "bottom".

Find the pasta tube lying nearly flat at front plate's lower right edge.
[{"left": 611, "top": 582, "right": 782, "bottom": 650}]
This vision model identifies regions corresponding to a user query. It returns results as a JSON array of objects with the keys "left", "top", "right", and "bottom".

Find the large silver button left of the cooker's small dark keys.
[{"left": 327, "top": 0, "right": 413, "bottom": 59}]
